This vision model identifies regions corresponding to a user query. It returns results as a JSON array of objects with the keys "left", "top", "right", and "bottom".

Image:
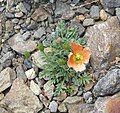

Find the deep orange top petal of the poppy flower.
[{"left": 71, "top": 42, "right": 83, "bottom": 54}]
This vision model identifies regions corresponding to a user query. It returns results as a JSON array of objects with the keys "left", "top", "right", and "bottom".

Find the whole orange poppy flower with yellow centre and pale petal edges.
[{"left": 67, "top": 42, "right": 91, "bottom": 72}]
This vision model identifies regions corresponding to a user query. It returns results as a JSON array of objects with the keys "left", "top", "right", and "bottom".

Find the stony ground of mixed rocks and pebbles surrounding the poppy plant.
[{"left": 0, "top": 0, "right": 120, "bottom": 113}]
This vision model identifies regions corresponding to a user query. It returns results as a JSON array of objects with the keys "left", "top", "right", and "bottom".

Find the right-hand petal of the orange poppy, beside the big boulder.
[{"left": 82, "top": 47, "right": 91, "bottom": 64}]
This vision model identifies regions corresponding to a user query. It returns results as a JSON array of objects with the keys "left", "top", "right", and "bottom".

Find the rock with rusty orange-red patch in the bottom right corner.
[{"left": 93, "top": 93, "right": 120, "bottom": 113}]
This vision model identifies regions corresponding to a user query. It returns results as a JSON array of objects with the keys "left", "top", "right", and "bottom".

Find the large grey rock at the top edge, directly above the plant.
[{"left": 55, "top": 0, "right": 75, "bottom": 20}]
